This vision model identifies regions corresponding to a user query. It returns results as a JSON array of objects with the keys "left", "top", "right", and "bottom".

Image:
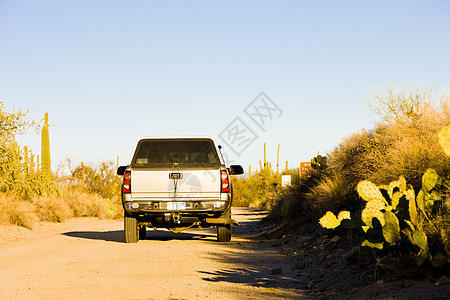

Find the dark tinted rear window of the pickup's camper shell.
[{"left": 131, "top": 139, "right": 220, "bottom": 169}]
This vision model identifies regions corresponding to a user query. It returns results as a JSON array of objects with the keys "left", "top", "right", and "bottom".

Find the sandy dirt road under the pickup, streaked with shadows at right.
[{"left": 0, "top": 208, "right": 302, "bottom": 299}]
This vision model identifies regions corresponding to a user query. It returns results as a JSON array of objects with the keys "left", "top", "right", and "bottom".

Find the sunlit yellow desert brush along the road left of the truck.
[{"left": 0, "top": 102, "right": 122, "bottom": 228}]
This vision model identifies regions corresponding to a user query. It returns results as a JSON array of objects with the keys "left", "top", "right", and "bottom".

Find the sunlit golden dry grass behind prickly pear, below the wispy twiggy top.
[{"left": 328, "top": 98, "right": 450, "bottom": 187}]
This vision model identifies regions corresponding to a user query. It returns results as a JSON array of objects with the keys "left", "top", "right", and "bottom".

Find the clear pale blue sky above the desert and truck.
[{"left": 0, "top": 0, "right": 450, "bottom": 170}]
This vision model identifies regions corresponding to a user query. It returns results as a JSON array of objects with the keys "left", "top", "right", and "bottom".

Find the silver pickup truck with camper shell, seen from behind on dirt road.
[{"left": 117, "top": 136, "right": 243, "bottom": 243}]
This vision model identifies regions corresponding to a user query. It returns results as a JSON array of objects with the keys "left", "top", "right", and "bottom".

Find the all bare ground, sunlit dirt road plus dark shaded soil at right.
[{"left": 0, "top": 208, "right": 450, "bottom": 299}]
